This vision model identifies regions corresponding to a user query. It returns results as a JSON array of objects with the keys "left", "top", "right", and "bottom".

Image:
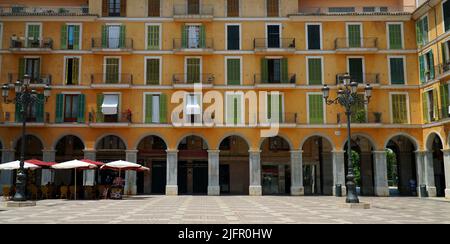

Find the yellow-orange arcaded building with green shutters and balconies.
[{"left": 0, "top": 0, "right": 450, "bottom": 197}]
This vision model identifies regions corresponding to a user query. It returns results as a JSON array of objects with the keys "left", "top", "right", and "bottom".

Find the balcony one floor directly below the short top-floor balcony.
[{"left": 173, "top": 38, "right": 214, "bottom": 55}]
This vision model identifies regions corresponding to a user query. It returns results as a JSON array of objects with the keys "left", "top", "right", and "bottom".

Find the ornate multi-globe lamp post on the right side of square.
[{"left": 322, "top": 73, "right": 372, "bottom": 203}]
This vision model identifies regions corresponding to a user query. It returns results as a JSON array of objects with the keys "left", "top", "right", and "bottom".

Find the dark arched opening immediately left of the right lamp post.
[{"left": 302, "top": 136, "right": 333, "bottom": 195}]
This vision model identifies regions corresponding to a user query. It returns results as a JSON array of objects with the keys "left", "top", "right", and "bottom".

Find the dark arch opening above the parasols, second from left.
[{"left": 55, "top": 135, "right": 85, "bottom": 163}]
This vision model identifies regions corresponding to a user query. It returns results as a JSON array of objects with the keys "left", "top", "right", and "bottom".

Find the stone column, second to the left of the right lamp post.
[{"left": 291, "top": 151, "right": 305, "bottom": 196}]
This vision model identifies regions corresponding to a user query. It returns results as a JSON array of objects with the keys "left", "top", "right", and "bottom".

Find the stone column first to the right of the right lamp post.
[{"left": 373, "top": 151, "right": 389, "bottom": 197}]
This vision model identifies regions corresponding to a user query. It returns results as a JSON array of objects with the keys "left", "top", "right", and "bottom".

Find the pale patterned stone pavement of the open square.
[{"left": 0, "top": 196, "right": 450, "bottom": 224}]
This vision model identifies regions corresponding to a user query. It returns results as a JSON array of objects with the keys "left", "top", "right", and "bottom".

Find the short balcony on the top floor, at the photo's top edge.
[{"left": 173, "top": 4, "right": 214, "bottom": 22}]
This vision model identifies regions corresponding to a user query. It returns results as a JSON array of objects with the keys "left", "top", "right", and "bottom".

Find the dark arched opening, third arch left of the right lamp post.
[{"left": 219, "top": 136, "right": 250, "bottom": 195}]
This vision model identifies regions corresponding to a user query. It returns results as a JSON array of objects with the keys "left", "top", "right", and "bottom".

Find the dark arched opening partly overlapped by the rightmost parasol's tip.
[{"left": 136, "top": 136, "right": 167, "bottom": 194}]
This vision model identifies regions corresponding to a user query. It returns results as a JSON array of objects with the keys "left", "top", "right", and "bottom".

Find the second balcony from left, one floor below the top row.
[{"left": 91, "top": 38, "right": 134, "bottom": 54}]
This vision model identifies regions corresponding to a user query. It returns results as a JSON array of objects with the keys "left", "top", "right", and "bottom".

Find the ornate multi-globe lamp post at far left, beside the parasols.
[{"left": 2, "top": 75, "right": 51, "bottom": 202}]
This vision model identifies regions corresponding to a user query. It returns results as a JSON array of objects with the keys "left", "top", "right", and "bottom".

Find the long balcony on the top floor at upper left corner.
[{"left": 0, "top": 6, "right": 95, "bottom": 16}]
